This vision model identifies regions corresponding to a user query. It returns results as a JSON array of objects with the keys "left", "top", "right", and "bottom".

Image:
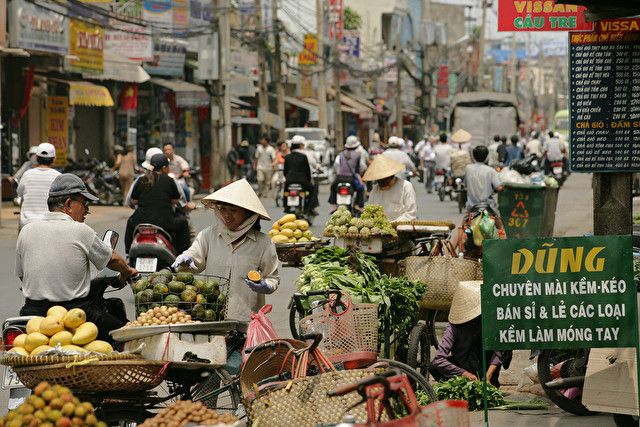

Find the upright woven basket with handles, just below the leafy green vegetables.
[{"left": 300, "top": 293, "right": 378, "bottom": 363}]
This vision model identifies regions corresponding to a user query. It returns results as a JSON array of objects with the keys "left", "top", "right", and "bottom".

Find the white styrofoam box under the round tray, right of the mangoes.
[{"left": 124, "top": 332, "right": 227, "bottom": 366}]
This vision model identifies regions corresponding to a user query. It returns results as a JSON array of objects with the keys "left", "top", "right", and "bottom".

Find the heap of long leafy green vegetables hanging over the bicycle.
[{"left": 297, "top": 246, "right": 426, "bottom": 351}]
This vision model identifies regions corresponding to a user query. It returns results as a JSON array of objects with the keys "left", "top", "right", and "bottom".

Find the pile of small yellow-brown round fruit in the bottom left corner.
[{"left": 0, "top": 382, "right": 107, "bottom": 427}]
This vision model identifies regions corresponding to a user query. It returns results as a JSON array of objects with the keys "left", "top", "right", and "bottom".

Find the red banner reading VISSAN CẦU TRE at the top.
[{"left": 498, "top": 0, "right": 593, "bottom": 31}]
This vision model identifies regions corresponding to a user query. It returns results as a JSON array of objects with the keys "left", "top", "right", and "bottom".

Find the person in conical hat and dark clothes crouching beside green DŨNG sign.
[{"left": 429, "top": 281, "right": 511, "bottom": 387}]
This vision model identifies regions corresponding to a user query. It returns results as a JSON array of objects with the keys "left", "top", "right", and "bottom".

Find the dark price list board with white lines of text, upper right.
[{"left": 569, "top": 19, "right": 640, "bottom": 172}]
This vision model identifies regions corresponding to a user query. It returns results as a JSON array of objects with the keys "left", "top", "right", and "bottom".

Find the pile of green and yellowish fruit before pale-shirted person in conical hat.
[{"left": 324, "top": 205, "right": 398, "bottom": 239}]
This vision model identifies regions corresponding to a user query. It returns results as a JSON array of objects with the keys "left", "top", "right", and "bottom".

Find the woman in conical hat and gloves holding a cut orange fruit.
[{"left": 172, "top": 179, "right": 280, "bottom": 320}]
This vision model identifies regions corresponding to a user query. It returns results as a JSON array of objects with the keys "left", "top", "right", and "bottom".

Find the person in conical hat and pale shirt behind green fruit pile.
[{"left": 362, "top": 157, "right": 418, "bottom": 222}]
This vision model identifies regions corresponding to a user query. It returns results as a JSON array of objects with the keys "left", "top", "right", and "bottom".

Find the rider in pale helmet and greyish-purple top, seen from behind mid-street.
[{"left": 329, "top": 135, "right": 366, "bottom": 211}]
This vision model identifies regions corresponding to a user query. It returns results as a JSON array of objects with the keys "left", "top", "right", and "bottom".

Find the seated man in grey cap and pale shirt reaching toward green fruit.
[{"left": 16, "top": 173, "right": 137, "bottom": 337}]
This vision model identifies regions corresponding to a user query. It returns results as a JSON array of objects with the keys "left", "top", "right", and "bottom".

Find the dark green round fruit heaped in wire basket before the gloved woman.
[{"left": 131, "top": 270, "right": 227, "bottom": 322}]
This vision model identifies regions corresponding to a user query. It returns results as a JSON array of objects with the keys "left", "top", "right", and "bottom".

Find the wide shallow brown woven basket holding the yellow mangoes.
[{"left": 15, "top": 360, "right": 167, "bottom": 392}]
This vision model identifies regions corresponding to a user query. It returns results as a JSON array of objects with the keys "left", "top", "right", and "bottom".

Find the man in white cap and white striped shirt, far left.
[{"left": 18, "top": 142, "right": 60, "bottom": 229}]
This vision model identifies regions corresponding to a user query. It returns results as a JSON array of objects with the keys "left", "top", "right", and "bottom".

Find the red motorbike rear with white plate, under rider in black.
[{"left": 128, "top": 224, "right": 177, "bottom": 273}]
